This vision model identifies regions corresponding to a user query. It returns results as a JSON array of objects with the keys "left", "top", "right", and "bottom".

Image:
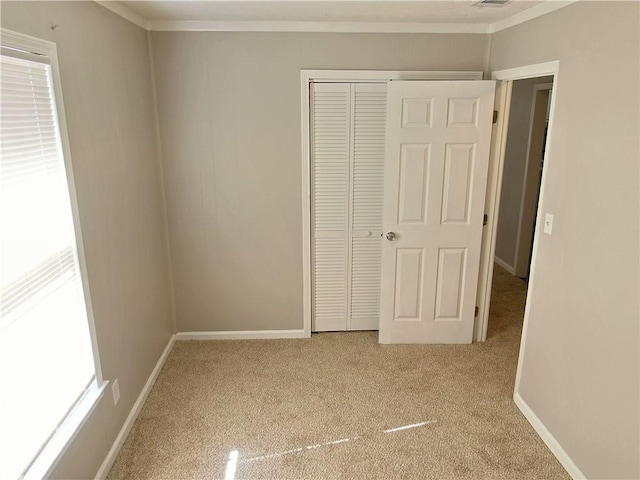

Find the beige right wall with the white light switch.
[{"left": 491, "top": 2, "right": 640, "bottom": 479}]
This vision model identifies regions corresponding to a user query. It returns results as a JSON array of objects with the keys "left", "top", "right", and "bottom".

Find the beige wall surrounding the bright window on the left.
[{"left": 2, "top": 2, "right": 173, "bottom": 478}]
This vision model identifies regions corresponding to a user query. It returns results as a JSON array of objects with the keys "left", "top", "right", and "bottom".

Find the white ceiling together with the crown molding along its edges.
[{"left": 98, "top": 0, "right": 576, "bottom": 33}]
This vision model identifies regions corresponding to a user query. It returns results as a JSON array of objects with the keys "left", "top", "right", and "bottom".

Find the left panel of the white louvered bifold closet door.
[{"left": 311, "top": 83, "right": 351, "bottom": 332}]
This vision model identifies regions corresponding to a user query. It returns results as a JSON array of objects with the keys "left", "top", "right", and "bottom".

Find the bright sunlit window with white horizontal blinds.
[{"left": 0, "top": 30, "right": 104, "bottom": 478}]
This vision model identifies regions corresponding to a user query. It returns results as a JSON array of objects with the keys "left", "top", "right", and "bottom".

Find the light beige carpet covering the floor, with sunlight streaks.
[{"left": 109, "top": 267, "right": 569, "bottom": 479}]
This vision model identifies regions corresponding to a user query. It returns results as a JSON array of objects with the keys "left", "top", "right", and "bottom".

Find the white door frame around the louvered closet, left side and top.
[{"left": 300, "top": 70, "right": 483, "bottom": 338}]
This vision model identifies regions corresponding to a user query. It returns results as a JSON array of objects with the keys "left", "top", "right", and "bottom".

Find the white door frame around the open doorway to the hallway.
[{"left": 474, "top": 60, "right": 560, "bottom": 344}]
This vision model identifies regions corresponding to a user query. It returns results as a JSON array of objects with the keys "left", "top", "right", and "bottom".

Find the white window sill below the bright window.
[{"left": 23, "top": 379, "right": 109, "bottom": 480}]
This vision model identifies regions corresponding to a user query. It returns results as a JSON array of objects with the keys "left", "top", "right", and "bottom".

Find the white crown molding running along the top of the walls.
[{"left": 94, "top": 0, "right": 580, "bottom": 34}]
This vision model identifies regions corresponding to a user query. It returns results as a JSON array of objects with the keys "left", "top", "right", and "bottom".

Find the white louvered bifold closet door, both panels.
[{"left": 311, "top": 83, "right": 386, "bottom": 331}]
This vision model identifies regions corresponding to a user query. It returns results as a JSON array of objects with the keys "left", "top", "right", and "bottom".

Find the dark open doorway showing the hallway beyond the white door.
[{"left": 487, "top": 76, "right": 553, "bottom": 344}]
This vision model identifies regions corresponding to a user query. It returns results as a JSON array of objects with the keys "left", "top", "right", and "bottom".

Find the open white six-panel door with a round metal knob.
[{"left": 379, "top": 81, "right": 495, "bottom": 343}]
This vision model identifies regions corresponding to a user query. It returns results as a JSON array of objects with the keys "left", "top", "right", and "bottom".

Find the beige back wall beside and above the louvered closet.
[{"left": 153, "top": 32, "right": 487, "bottom": 331}]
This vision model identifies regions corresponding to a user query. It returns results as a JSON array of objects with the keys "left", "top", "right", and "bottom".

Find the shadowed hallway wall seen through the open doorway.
[{"left": 496, "top": 77, "right": 553, "bottom": 271}]
